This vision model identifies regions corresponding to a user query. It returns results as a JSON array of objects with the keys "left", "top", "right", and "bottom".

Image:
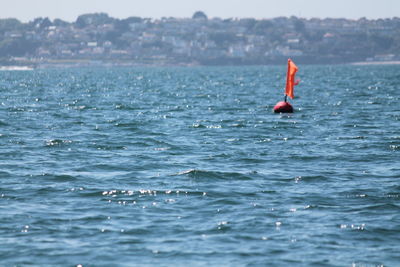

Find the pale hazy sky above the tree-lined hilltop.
[{"left": 0, "top": 0, "right": 400, "bottom": 22}]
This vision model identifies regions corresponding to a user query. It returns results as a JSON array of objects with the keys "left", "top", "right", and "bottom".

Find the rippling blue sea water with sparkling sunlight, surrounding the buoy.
[{"left": 0, "top": 65, "right": 400, "bottom": 267}]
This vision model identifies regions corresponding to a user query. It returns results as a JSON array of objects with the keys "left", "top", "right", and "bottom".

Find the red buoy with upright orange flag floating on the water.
[{"left": 274, "top": 58, "right": 300, "bottom": 113}]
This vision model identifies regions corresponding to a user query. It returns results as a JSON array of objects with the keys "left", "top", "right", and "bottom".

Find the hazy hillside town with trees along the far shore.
[{"left": 0, "top": 11, "right": 400, "bottom": 67}]
